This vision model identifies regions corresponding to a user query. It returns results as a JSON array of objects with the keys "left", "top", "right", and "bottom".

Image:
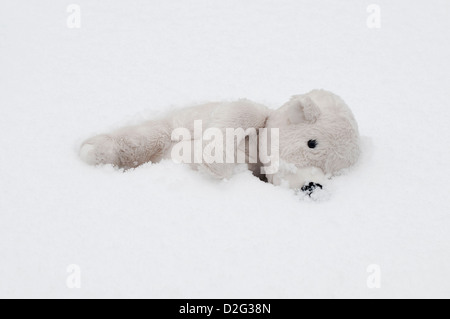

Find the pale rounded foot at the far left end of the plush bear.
[{"left": 80, "top": 135, "right": 118, "bottom": 165}]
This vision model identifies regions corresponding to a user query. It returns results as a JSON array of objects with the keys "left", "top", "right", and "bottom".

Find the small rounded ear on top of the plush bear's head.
[{"left": 287, "top": 95, "right": 322, "bottom": 124}]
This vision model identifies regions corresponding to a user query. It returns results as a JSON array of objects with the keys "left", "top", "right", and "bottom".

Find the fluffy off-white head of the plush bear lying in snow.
[{"left": 267, "top": 90, "right": 360, "bottom": 188}]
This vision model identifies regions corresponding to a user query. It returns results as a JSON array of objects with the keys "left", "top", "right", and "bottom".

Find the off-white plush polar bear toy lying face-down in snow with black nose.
[{"left": 80, "top": 90, "right": 360, "bottom": 195}]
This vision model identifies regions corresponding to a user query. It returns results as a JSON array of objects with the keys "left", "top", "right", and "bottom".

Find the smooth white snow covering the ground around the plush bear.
[{"left": 0, "top": 0, "right": 450, "bottom": 298}]
